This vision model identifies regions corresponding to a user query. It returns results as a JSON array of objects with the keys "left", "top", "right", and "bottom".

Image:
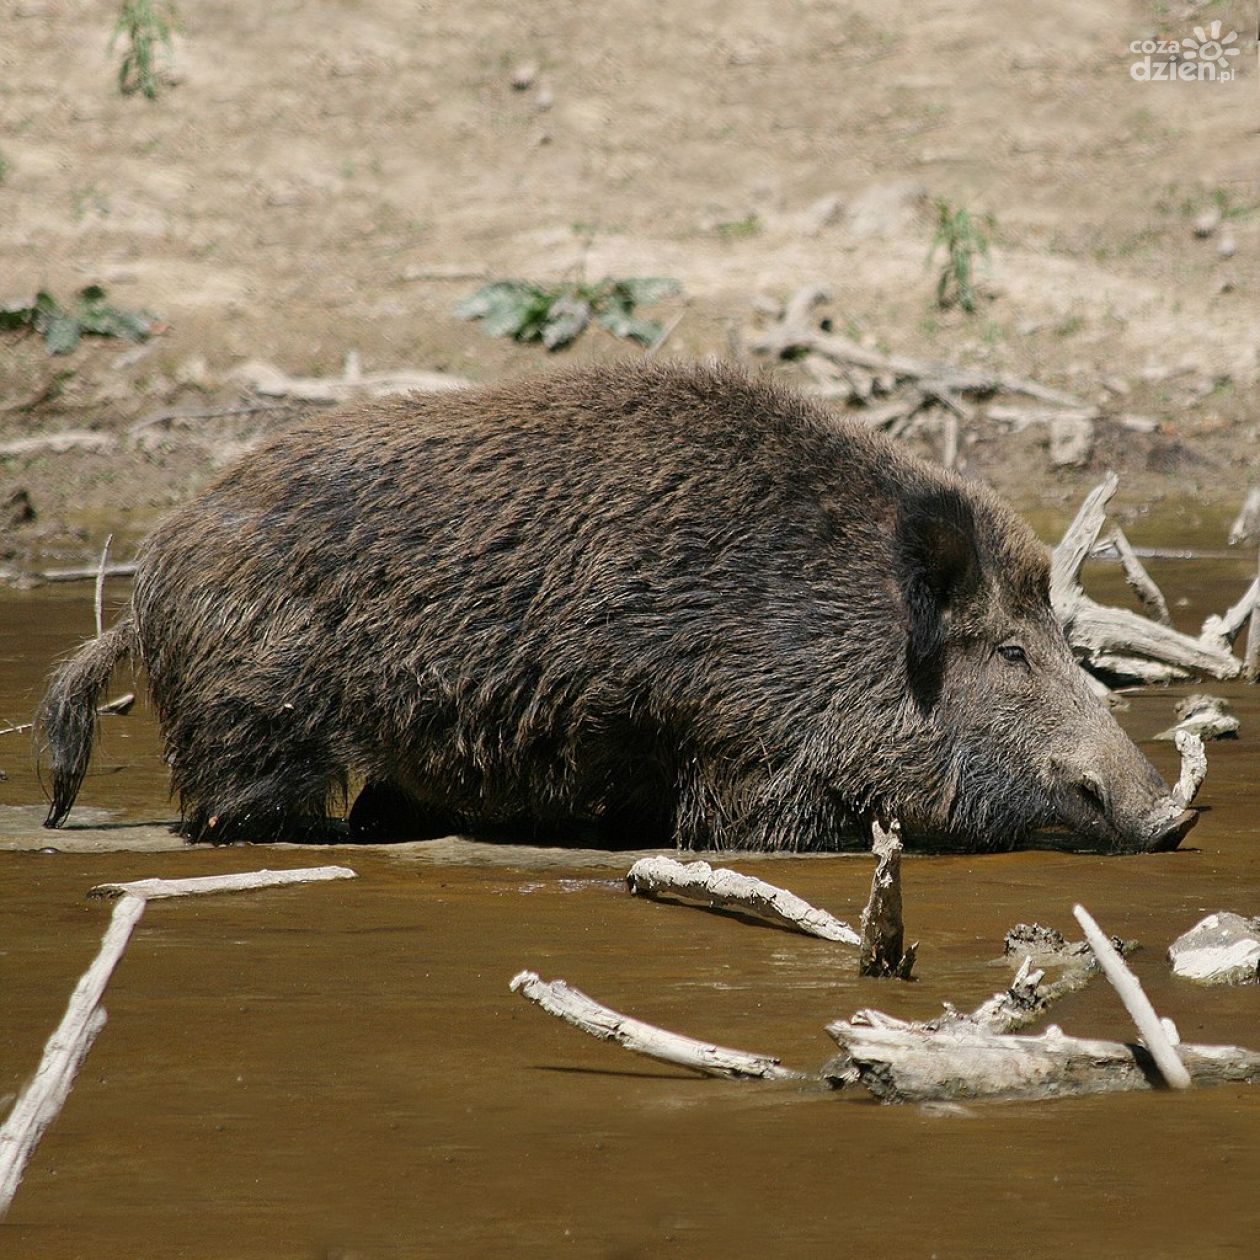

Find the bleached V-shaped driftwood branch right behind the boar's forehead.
[{"left": 1050, "top": 473, "right": 1242, "bottom": 682}]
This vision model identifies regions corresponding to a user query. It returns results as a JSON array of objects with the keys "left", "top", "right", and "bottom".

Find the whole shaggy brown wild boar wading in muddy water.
[{"left": 39, "top": 362, "right": 1196, "bottom": 851}]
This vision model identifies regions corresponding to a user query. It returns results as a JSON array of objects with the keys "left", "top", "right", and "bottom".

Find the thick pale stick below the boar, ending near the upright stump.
[{"left": 626, "top": 858, "right": 861, "bottom": 945}]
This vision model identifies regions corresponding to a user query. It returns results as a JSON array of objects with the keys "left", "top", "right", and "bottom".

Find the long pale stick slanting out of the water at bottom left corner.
[{"left": 0, "top": 897, "right": 145, "bottom": 1217}]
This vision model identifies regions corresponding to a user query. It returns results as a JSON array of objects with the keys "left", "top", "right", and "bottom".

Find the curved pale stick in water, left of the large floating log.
[{"left": 510, "top": 971, "right": 801, "bottom": 1080}]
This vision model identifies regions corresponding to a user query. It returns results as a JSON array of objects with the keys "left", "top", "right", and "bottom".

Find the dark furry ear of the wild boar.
[{"left": 896, "top": 488, "right": 980, "bottom": 708}]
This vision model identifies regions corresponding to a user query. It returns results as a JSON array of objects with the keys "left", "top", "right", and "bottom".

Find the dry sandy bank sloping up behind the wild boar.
[{"left": 0, "top": 0, "right": 1260, "bottom": 563}]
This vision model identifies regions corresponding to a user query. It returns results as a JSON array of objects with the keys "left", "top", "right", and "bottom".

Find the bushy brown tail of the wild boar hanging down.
[{"left": 35, "top": 609, "right": 135, "bottom": 827}]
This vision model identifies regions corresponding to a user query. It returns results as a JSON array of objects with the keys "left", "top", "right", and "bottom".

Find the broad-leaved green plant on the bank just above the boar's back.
[{"left": 455, "top": 276, "right": 679, "bottom": 350}]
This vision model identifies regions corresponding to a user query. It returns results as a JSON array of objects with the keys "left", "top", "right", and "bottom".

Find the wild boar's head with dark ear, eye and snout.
[{"left": 895, "top": 485, "right": 1197, "bottom": 852}]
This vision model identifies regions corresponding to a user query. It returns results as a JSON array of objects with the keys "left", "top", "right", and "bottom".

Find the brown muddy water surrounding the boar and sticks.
[{"left": 0, "top": 558, "right": 1260, "bottom": 1260}]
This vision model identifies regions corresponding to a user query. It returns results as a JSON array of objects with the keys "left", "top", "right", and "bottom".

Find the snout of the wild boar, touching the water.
[{"left": 1058, "top": 737, "right": 1198, "bottom": 853}]
